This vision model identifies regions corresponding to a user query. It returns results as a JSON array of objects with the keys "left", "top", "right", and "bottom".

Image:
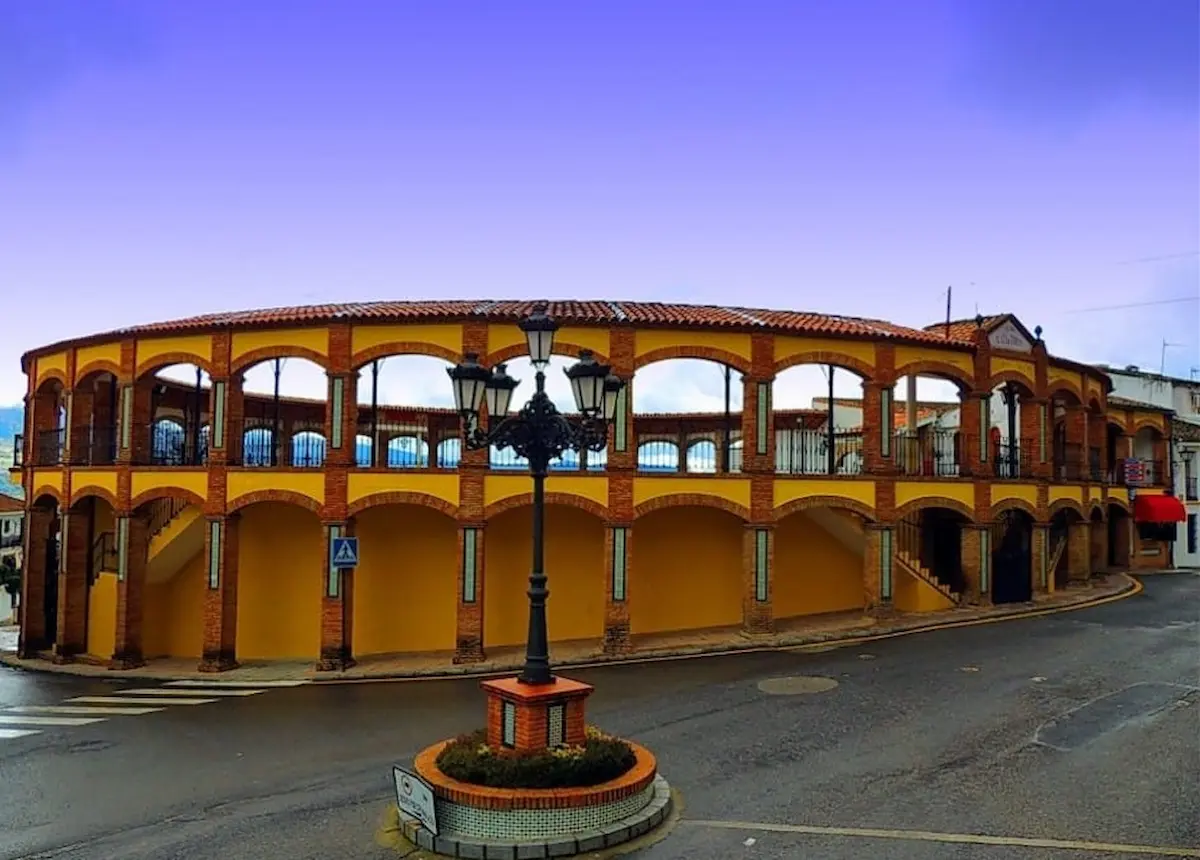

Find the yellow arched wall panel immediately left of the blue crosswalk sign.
[{"left": 238, "top": 503, "right": 325, "bottom": 660}]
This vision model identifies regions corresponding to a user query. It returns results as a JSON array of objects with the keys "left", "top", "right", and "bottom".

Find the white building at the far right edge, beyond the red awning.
[{"left": 1100, "top": 365, "right": 1200, "bottom": 567}]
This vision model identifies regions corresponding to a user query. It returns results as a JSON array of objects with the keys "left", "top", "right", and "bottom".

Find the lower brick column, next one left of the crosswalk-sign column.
[{"left": 198, "top": 513, "right": 241, "bottom": 672}]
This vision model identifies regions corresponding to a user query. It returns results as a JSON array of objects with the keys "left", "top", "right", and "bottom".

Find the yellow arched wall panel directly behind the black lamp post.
[{"left": 484, "top": 505, "right": 605, "bottom": 648}]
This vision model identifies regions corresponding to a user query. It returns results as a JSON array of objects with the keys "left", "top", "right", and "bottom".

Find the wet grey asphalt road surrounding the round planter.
[{"left": 0, "top": 573, "right": 1200, "bottom": 860}]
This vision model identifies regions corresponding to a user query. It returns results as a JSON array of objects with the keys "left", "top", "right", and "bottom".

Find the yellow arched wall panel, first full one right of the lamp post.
[{"left": 629, "top": 507, "right": 744, "bottom": 633}]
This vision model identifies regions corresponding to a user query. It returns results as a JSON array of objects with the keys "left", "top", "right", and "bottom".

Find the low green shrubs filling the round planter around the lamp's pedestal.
[{"left": 438, "top": 726, "right": 637, "bottom": 788}]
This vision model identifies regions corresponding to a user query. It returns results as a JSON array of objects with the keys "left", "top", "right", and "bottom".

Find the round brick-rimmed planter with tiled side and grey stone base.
[{"left": 406, "top": 741, "right": 671, "bottom": 858}]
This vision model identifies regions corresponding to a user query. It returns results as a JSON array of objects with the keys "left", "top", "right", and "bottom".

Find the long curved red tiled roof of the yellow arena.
[{"left": 26, "top": 300, "right": 972, "bottom": 364}]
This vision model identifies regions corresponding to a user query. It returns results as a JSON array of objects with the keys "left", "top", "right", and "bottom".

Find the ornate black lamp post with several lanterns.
[{"left": 446, "top": 305, "right": 625, "bottom": 684}]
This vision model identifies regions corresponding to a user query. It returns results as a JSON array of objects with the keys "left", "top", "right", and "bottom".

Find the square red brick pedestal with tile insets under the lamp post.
[{"left": 480, "top": 678, "right": 594, "bottom": 752}]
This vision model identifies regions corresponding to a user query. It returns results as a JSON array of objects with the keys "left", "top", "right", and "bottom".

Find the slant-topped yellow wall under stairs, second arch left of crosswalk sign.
[{"left": 142, "top": 552, "right": 206, "bottom": 660}]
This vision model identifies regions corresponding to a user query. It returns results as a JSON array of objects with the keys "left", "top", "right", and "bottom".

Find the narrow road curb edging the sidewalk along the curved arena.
[{"left": 0, "top": 571, "right": 1142, "bottom": 686}]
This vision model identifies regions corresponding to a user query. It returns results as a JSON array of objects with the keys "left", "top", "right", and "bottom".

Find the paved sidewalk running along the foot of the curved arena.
[{"left": 0, "top": 573, "right": 1140, "bottom": 684}]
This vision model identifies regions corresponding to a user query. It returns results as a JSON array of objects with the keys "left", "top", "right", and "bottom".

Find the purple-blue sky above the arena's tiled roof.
[{"left": 0, "top": 0, "right": 1200, "bottom": 410}]
